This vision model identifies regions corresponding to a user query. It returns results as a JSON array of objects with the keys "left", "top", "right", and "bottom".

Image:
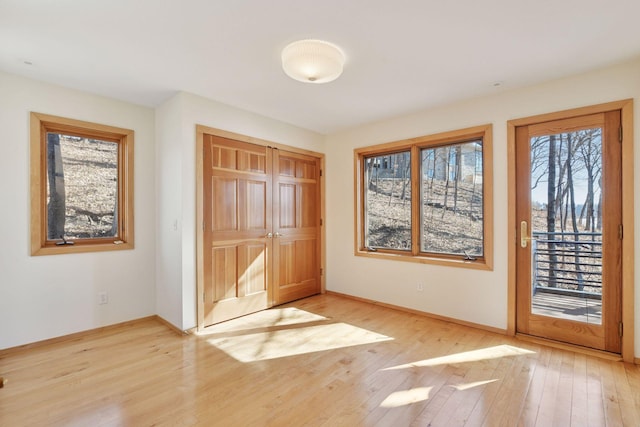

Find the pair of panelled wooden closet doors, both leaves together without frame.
[{"left": 199, "top": 134, "right": 320, "bottom": 326}]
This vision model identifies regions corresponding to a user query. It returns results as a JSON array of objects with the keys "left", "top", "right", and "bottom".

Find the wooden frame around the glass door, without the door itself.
[{"left": 507, "top": 99, "right": 635, "bottom": 363}]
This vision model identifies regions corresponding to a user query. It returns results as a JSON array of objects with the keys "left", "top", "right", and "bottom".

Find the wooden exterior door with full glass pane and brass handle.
[{"left": 516, "top": 111, "right": 622, "bottom": 353}]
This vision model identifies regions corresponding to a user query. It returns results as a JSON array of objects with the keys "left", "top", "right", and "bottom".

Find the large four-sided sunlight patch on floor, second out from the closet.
[{"left": 207, "top": 323, "right": 393, "bottom": 363}]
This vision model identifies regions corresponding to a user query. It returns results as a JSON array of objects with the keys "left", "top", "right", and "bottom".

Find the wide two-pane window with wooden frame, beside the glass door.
[{"left": 355, "top": 125, "right": 493, "bottom": 269}]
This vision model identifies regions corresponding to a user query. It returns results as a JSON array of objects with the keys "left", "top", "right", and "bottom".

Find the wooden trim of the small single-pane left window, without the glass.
[{"left": 30, "top": 112, "right": 134, "bottom": 256}]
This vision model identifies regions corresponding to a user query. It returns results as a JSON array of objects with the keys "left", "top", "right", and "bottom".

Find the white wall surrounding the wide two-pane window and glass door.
[{"left": 326, "top": 60, "right": 640, "bottom": 356}]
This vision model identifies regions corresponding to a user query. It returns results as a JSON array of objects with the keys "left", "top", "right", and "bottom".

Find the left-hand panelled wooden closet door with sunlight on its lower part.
[{"left": 202, "top": 134, "right": 273, "bottom": 326}]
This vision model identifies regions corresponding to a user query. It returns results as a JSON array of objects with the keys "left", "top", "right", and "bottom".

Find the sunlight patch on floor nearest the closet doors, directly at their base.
[{"left": 197, "top": 307, "right": 327, "bottom": 336}]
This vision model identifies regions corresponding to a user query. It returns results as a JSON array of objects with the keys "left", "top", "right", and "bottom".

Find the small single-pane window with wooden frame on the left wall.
[{"left": 31, "top": 113, "right": 133, "bottom": 255}]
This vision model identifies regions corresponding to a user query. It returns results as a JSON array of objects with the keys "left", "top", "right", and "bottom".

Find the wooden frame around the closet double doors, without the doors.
[{"left": 196, "top": 124, "right": 326, "bottom": 331}]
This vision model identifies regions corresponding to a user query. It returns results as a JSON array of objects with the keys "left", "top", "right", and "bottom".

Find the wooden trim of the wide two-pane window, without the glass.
[{"left": 354, "top": 124, "right": 493, "bottom": 270}]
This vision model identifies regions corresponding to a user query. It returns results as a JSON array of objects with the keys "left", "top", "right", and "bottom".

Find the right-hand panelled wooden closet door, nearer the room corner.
[{"left": 273, "top": 149, "right": 320, "bottom": 305}]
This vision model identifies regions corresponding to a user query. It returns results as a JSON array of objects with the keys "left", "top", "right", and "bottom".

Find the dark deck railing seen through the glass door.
[{"left": 531, "top": 231, "right": 602, "bottom": 299}]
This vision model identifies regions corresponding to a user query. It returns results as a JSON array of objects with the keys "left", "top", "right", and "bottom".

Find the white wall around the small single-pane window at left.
[{"left": 0, "top": 72, "right": 155, "bottom": 349}]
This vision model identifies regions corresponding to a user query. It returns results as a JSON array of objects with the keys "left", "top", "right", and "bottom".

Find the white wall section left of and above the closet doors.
[{"left": 156, "top": 93, "right": 324, "bottom": 330}]
